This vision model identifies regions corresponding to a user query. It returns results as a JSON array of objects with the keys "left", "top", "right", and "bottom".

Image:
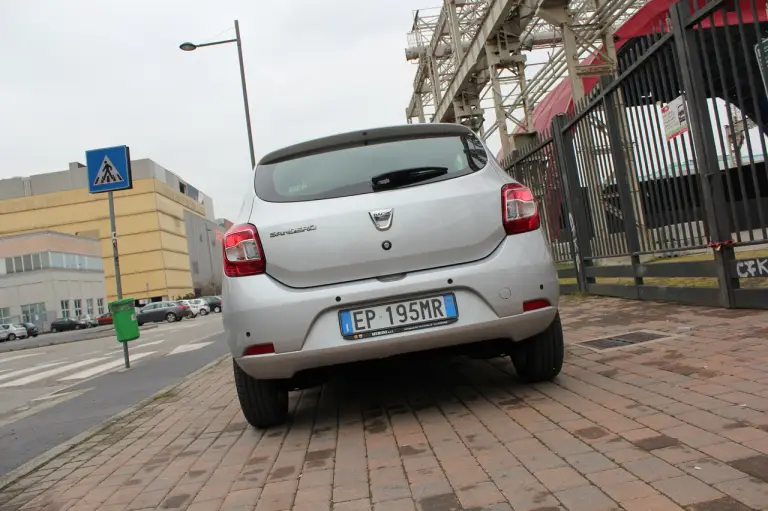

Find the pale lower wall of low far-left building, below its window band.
[{"left": 0, "top": 270, "right": 107, "bottom": 329}]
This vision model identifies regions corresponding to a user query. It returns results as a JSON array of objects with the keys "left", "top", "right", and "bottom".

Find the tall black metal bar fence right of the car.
[{"left": 503, "top": 0, "right": 768, "bottom": 308}]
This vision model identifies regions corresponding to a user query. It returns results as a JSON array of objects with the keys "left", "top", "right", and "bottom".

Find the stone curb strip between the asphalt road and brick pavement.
[{"left": 0, "top": 354, "right": 231, "bottom": 491}]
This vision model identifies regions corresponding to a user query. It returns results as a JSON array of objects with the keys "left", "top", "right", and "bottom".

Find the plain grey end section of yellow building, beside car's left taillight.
[{"left": 184, "top": 211, "right": 224, "bottom": 292}]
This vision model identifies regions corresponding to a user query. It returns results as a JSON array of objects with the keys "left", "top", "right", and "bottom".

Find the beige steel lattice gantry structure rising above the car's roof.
[{"left": 406, "top": 0, "right": 648, "bottom": 156}]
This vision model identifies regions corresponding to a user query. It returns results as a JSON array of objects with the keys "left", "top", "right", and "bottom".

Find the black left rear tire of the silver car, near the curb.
[{"left": 232, "top": 359, "right": 288, "bottom": 428}]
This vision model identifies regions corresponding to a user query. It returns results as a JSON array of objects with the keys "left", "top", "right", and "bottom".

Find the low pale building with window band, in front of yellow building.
[{"left": 0, "top": 231, "right": 107, "bottom": 329}]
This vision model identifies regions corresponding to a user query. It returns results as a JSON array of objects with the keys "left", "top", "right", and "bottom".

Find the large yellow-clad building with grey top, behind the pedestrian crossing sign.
[{"left": 0, "top": 159, "right": 222, "bottom": 304}]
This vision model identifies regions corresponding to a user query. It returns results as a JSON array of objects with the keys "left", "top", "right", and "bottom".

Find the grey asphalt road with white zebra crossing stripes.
[{"left": 0, "top": 314, "right": 228, "bottom": 476}]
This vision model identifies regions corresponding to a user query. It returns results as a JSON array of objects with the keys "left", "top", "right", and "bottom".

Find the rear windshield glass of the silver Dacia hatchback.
[{"left": 255, "top": 134, "right": 488, "bottom": 202}]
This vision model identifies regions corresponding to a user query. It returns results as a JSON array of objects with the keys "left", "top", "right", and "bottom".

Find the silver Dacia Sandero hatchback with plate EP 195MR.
[{"left": 223, "top": 124, "right": 563, "bottom": 427}]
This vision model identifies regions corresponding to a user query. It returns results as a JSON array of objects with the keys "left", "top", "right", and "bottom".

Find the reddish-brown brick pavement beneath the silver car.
[{"left": 0, "top": 298, "right": 768, "bottom": 511}]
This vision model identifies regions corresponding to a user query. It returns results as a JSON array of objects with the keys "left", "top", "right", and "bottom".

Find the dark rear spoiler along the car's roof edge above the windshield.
[{"left": 259, "top": 123, "right": 473, "bottom": 165}]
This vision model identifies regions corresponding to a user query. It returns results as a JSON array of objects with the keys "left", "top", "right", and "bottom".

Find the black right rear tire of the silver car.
[{"left": 512, "top": 313, "right": 565, "bottom": 383}]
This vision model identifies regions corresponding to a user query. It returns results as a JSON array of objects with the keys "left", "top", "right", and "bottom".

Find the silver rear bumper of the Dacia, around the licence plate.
[{"left": 223, "top": 231, "right": 559, "bottom": 379}]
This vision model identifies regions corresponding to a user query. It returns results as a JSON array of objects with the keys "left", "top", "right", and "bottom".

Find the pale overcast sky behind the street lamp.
[{"left": 0, "top": 0, "right": 426, "bottom": 218}]
